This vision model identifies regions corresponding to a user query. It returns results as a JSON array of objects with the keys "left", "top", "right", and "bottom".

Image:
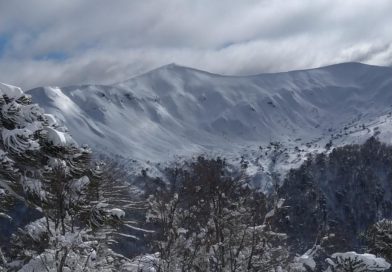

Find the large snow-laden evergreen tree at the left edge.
[{"left": 0, "top": 84, "right": 129, "bottom": 271}]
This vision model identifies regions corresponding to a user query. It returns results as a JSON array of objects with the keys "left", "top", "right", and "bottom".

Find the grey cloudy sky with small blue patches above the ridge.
[{"left": 0, "top": 0, "right": 392, "bottom": 89}]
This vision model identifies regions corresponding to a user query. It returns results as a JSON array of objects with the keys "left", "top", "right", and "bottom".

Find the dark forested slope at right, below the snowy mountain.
[{"left": 277, "top": 138, "right": 392, "bottom": 251}]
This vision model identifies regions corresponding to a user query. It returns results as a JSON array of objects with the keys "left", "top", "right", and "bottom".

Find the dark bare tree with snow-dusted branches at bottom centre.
[{"left": 141, "top": 157, "right": 288, "bottom": 271}]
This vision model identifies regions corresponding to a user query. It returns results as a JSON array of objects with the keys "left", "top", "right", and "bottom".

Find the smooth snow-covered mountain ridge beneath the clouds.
[{"left": 28, "top": 63, "right": 392, "bottom": 185}]
